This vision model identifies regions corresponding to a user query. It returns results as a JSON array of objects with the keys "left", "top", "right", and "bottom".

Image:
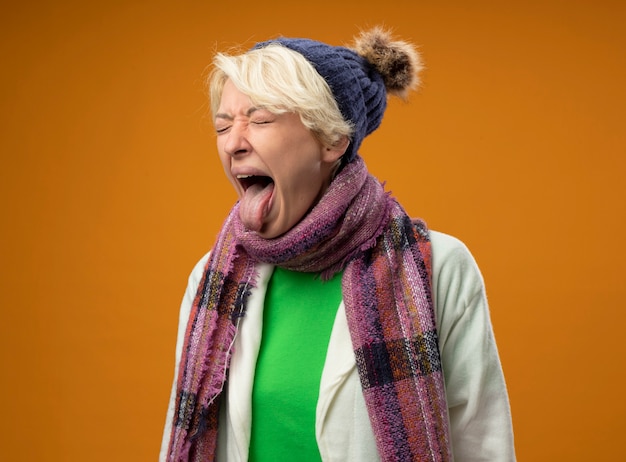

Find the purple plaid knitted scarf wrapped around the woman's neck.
[{"left": 168, "top": 156, "right": 451, "bottom": 461}]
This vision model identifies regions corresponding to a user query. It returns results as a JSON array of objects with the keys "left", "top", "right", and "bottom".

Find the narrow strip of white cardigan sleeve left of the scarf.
[{"left": 159, "top": 253, "right": 209, "bottom": 462}]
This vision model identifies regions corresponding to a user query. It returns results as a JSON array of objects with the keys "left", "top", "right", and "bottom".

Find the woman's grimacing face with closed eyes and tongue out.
[{"left": 215, "top": 80, "right": 347, "bottom": 239}]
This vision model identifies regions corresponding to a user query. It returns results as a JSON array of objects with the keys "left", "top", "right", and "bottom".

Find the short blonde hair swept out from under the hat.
[{"left": 208, "top": 43, "right": 353, "bottom": 146}]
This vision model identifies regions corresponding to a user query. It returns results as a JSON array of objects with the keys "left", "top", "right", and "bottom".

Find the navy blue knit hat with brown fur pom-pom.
[{"left": 253, "top": 27, "right": 422, "bottom": 162}]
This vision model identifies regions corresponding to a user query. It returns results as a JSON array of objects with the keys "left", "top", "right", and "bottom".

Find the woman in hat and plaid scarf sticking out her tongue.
[{"left": 161, "top": 28, "right": 515, "bottom": 461}]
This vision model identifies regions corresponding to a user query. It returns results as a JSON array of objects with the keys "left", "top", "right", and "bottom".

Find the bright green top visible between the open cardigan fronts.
[{"left": 249, "top": 268, "right": 341, "bottom": 462}]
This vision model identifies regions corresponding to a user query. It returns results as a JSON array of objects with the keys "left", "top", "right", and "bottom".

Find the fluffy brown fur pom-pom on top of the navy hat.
[{"left": 351, "top": 27, "right": 423, "bottom": 98}]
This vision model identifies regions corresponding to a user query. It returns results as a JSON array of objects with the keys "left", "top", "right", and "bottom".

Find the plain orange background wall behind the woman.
[{"left": 0, "top": 0, "right": 626, "bottom": 461}]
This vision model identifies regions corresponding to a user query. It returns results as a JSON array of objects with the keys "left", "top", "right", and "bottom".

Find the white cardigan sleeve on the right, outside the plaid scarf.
[{"left": 431, "top": 232, "right": 515, "bottom": 462}]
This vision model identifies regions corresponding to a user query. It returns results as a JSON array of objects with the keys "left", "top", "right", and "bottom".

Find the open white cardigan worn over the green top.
[{"left": 159, "top": 231, "right": 515, "bottom": 462}]
